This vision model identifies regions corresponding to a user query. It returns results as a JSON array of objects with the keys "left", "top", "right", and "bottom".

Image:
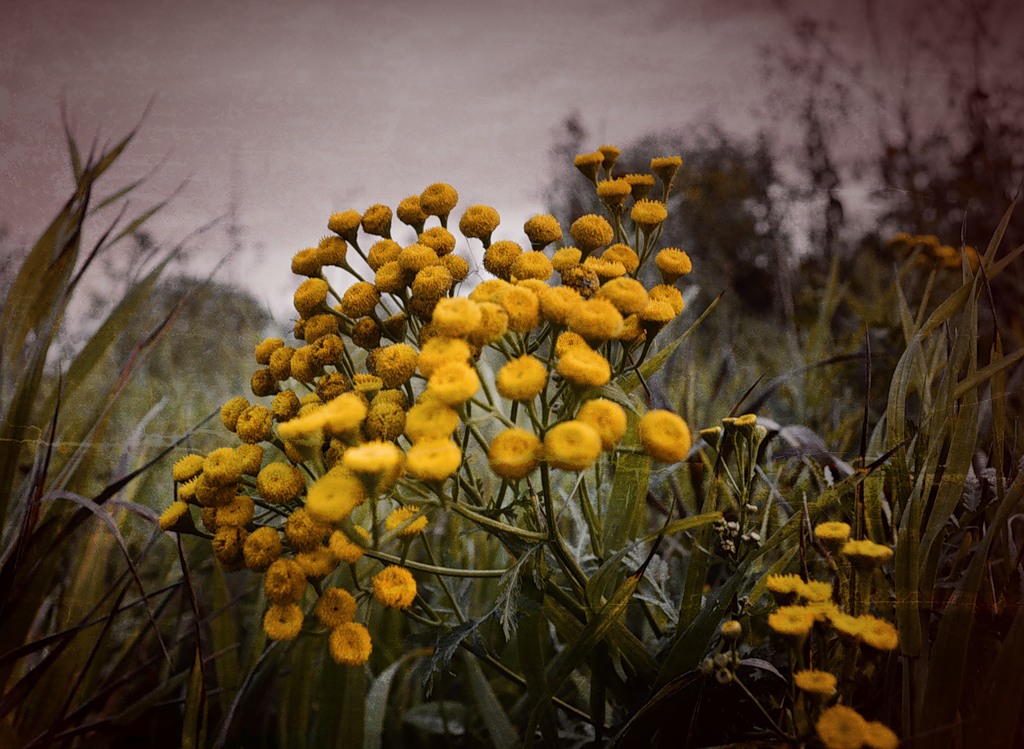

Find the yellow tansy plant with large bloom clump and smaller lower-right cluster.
[{"left": 160, "top": 147, "right": 909, "bottom": 746}]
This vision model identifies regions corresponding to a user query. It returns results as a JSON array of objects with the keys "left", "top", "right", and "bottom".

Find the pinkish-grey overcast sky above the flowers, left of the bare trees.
[{"left": 0, "top": 0, "right": 991, "bottom": 315}]
